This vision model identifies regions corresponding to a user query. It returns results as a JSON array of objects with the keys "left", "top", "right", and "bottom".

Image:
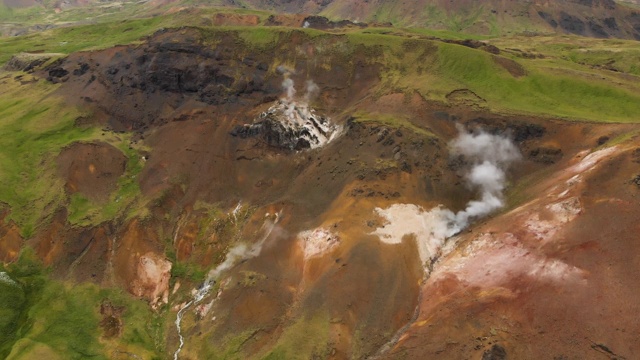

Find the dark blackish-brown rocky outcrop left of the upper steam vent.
[{"left": 42, "top": 28, "right": 280, "bottom": 131}]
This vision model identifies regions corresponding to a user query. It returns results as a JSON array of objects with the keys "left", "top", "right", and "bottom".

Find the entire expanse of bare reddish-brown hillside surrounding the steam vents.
[{"left": 8, "top": 29, "right": 640, "bottom": 359}]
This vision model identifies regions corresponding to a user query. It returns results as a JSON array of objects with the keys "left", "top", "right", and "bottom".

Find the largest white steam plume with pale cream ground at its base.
[{"left": 373, "top": 126, "right": 521, "bottom": 262}]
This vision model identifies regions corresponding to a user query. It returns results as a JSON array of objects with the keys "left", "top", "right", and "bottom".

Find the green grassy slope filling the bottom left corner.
[{"left": 0, "top": 248, "right": 166, "bottom": 359}]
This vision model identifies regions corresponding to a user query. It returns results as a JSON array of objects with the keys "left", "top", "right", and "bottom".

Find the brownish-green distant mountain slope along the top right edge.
[{"left": 242, "top": 0, "right": 640, "bottom": 39}]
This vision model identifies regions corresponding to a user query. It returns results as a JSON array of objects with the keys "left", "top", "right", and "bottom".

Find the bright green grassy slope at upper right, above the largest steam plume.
[{"left": 424, "top": 44, "right": 640, "bottom": 122}]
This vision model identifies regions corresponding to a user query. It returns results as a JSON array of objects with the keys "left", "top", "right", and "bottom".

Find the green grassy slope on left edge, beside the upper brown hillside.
[{"left": 0, "top": 73, "right": 96, "bottom": 238}]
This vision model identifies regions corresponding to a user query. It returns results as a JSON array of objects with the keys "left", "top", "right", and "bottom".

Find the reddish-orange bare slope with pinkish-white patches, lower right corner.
[{"left": 386, "top": 141, "right": 640, "bottom": 359}]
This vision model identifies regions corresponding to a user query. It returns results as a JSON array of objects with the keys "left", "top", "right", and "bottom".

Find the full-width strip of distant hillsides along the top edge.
[{"left": 0, "top": 0, "right": 640, "bottom": 40}]
